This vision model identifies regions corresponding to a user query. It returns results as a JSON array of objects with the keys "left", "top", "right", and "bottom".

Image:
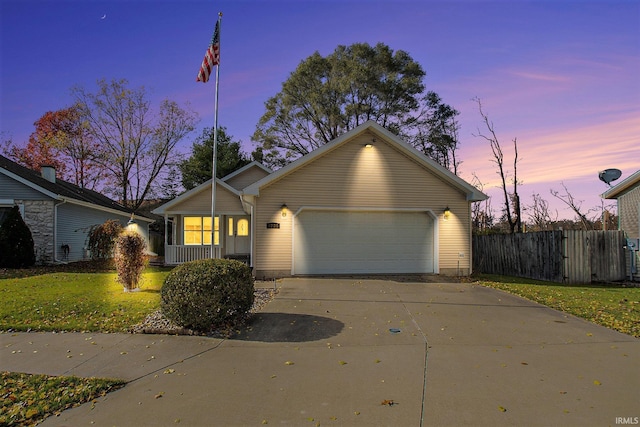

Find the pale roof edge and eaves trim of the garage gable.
[{"left": 243, "top": 120, "right": 488, "bottom": 202}]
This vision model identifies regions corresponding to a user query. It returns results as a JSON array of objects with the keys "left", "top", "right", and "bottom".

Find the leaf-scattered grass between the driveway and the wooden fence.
[{"left": 474, "top": 274, "right": 640, "bottom": 338}]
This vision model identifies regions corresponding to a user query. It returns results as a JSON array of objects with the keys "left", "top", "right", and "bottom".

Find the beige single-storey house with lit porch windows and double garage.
[{"left": 154, "top": 121, "right": 487, "bottom": 278}]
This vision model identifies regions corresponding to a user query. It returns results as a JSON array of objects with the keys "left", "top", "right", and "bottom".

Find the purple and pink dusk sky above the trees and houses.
[{"left": 0, "top": 0, "right": 640, "bottom": 218}]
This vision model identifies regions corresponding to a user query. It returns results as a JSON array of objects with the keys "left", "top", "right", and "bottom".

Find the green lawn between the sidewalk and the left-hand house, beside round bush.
[{"left": 0, "top": 267, "right": 170, "bottom": 332}]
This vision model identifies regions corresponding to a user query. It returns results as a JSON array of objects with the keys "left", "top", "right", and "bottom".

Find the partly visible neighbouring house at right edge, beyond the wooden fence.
[{"left": 602, "top": 170, "right": 640, "bottom": 279}]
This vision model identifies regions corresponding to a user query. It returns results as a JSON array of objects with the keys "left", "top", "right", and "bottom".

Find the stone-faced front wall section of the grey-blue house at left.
[{"left": 15, "top": 200, "right": 54, "bottom": 264}]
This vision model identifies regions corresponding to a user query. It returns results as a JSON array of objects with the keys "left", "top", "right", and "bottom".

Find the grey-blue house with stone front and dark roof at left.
[{"left": 0, "top": 156, "right": 153, "bottom": 264}]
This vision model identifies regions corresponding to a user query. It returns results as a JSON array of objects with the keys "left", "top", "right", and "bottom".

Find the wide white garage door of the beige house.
[{"left": 293, "top": 210, "right": 434, "bottom": 274}]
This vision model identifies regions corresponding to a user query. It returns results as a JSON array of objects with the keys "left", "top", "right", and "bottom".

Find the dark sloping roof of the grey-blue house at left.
[{"left": 0, "top": 155, "right": 153, "bottom": 222}]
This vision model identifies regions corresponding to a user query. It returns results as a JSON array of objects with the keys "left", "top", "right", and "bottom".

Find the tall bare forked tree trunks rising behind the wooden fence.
[{"left": 473, "top": 97, "right": 522, "bottom": 233}]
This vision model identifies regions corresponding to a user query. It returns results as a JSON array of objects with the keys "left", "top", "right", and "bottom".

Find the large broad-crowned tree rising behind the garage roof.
[{"left": 252, "top": 43, "right": 457, "bottom": 172}]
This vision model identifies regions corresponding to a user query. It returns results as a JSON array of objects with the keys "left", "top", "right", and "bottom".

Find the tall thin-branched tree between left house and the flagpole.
[{"left": 72, "top": 79, "right": 197, "bottom": 210}]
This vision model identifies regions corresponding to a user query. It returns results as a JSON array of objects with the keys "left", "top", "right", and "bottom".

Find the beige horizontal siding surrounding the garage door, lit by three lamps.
[{"left": 254, "top": 132, "right": 471, "bottom": 274}]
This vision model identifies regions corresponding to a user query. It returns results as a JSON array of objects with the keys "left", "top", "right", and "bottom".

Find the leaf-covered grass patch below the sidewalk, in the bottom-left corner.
[{"left": 0, "top": 372, "right": 125, "bottom": 426}]
